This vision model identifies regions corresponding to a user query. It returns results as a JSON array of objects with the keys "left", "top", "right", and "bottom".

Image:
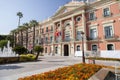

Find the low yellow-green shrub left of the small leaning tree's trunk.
[{"left": 19, "top": 54, "right": 35, "bottom": 62}]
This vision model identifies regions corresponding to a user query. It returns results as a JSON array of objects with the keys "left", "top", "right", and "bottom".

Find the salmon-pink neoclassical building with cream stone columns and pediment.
[{"left": 14, "top": 0, "right": 120, "bottom": 56}]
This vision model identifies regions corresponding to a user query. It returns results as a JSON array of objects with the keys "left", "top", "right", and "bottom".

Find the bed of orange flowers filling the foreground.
[{"left": 18, "top": 64, "right": 102, "bottom": 80}]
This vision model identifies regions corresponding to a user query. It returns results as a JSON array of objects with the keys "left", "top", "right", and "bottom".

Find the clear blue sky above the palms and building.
[{"left": 0, "top": 0, "right": 71, "bottom": 35}]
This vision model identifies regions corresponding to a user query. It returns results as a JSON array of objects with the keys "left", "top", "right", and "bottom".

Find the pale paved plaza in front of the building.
[{"left": 0, "top": 56, "right": 118, "bottom": 80}]
